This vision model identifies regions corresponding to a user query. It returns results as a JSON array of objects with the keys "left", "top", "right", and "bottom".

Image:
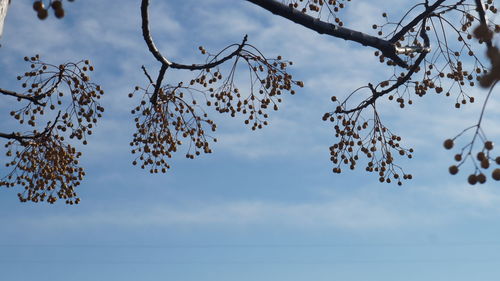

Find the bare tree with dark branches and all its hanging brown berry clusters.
[{"left": 0, "top": 0, "right": 500, "bottom": 204}]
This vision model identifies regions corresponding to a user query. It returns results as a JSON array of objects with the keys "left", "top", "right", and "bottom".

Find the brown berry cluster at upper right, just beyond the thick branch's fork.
[{"left": 372, "top": 1, "right": 500, "bottom": 108}]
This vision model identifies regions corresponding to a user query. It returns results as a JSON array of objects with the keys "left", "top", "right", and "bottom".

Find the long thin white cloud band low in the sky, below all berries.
[{"left": 14, "top": 184, "right": 500, "bottom": 232}]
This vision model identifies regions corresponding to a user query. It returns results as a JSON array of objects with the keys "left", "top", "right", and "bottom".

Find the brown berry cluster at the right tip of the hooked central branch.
[{"left": 189, "top": 47, "right": 304, "bottom": 130}]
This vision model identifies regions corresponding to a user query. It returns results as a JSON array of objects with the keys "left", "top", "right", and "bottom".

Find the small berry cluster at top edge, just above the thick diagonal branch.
[{"left": 284, "top": 0, "right": 351, "bottom": 26}]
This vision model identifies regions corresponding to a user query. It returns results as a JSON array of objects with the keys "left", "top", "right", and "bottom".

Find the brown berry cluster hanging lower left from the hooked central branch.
[{"left": 129, "top": 83, "right": 217, "bottom": 173}]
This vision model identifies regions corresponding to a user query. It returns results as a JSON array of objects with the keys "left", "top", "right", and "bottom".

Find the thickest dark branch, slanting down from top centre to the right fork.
[{"left": 247, "top": 0, "right": 408, "bottom": 68}]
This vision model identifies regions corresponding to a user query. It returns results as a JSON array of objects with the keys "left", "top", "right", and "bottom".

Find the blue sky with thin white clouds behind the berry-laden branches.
[{"left": 0, "top": 0, "right": 500, "bottom": 281}]
